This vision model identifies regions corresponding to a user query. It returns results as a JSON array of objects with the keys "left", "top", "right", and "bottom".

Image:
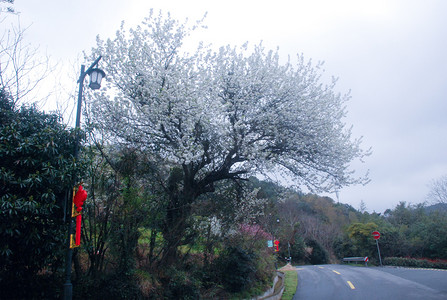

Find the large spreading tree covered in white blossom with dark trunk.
[{"left": 88, "top": 12, "right": 369, "bottom": 264}]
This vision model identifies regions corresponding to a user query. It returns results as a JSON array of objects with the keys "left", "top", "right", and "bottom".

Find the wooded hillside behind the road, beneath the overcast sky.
[{"left": 252, "top": 179, "right": 447, "bottom": 264}]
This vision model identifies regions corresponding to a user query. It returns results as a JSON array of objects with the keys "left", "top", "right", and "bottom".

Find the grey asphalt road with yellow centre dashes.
[{"left": 293, "top": 265, "right": 447, "bottom": 300}]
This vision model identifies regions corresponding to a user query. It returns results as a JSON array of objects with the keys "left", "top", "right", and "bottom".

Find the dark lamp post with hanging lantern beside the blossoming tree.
[{"left": 64, "top": 56, "right": 106, "bottom": 300}]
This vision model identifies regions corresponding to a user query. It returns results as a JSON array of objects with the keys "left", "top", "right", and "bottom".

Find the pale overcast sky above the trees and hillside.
[{"left": 4, "top": 0, "right": 447, "bottom": 212}]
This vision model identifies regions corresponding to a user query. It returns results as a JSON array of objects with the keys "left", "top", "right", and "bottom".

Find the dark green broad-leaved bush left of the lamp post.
[{"left": 0, "top": 91, "right": 79, "bottom": 297}]
